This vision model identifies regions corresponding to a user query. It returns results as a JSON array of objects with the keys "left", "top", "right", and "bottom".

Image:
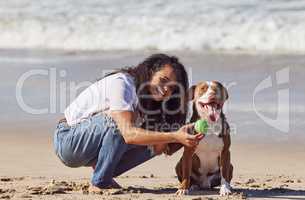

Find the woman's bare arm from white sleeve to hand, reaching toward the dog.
[{"left": 110, "top": 111, "right": 203, "bottom": 147}]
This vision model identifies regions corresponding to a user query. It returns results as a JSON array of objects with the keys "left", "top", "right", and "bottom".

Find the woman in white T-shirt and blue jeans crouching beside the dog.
[{"left": 54, "top": 54, "right": 202, "bottom": 189}]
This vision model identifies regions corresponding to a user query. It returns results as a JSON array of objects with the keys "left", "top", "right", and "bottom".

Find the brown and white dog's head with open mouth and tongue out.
[{"left": 188, "top": 81, "right": 229, "bottom": 122}]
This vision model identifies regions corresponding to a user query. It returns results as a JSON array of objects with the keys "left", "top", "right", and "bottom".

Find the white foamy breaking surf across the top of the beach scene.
[{"left": 0, "top": 0, "right": 305, "bottom": 53}]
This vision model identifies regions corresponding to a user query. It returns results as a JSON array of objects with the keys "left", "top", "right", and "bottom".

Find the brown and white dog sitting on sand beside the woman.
[{"left": 176, "top": 81, "right": 233, "bottom": 196}]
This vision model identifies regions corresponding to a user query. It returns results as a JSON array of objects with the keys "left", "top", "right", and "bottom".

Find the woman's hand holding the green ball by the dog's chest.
[{"left": 174, "top": 123, "right": 204, "bottom": 147}]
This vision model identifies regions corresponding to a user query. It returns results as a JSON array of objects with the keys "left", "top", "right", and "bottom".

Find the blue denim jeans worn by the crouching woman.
[{"left": 54, "top": 113, "right": 154, "bottom": 188}]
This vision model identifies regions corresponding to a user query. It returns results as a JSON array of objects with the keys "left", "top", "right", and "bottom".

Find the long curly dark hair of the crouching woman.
[{"left": 106, "top": 54, "right": 189, "bottom": 132}]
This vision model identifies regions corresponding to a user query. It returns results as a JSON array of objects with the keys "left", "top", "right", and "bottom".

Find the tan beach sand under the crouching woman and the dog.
[{"left": 0, "top": 134, "right": 305, "bottom": 200}]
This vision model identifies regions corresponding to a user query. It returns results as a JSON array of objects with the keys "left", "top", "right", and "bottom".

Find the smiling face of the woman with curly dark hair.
[{"left": 149, "top": 65, "right": 176, "bottom": 101}]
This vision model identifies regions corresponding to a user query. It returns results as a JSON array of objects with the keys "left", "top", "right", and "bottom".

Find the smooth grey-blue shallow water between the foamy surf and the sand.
[{"left": 0, "top": 51, "right": 305, "bottom": 143}]
